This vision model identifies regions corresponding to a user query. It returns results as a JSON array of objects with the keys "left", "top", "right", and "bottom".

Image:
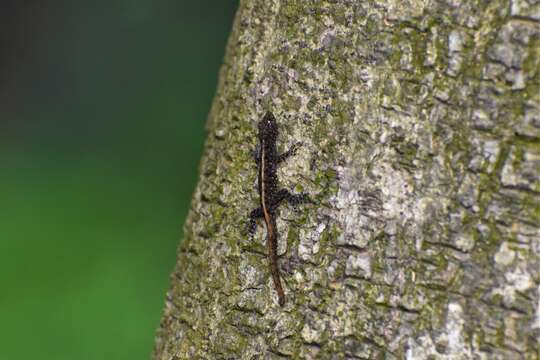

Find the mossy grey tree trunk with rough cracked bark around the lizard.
[{"left": 154, "top": 0, "right": 540, "bottom": 360}]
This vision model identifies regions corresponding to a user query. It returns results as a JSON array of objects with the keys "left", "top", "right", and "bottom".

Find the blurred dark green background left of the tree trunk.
[{"left": 0, "top": 0, "right": 237, "bottom": 360}]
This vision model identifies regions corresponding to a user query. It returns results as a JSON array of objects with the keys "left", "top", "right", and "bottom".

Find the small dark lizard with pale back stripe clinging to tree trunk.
[{"left": 248, "top": 112, "right": 308, "bottom": 306}]
